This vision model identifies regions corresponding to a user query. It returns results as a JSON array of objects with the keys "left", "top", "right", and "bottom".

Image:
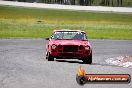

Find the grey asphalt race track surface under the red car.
[{"left": 0, "top": 39, "right": 132, "bottom": 88}]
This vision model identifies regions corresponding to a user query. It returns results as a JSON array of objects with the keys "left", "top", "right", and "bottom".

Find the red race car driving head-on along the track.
[{"left": 46, "top": 29, "right": 92, "bottom": 64}]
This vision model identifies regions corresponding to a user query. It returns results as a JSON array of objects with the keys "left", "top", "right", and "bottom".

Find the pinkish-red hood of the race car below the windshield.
[{"left": 50, "top": 40, "right": 91, "bottom": 46}]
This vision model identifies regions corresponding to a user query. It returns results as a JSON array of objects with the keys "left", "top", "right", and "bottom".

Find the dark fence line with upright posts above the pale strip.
[{"left": 4, "top": 0, "right": 132, "bottom": 7}]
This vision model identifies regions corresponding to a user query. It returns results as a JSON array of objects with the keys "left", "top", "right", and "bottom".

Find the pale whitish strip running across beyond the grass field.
[{"left": 0, "top": 0, "right": 132, "bottom": 13}]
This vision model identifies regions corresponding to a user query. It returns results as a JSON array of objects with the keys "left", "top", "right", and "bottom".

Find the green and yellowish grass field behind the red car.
[{"left": 0, "top": 6, "right": 132, "bottom": 40}]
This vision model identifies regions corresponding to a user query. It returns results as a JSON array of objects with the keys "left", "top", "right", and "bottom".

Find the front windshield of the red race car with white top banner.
[{"left": 51, "top": 31, "right": 87, "bottom": 40}]
